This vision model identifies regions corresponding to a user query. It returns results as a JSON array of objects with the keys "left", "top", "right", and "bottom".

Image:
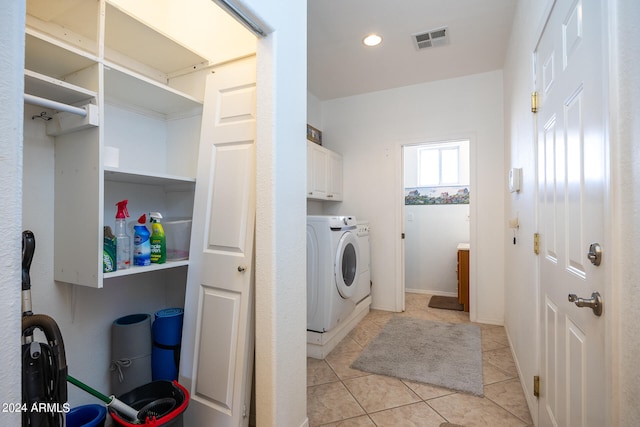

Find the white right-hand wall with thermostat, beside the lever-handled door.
[{"left": 504, "top": 1, "right": 546, "bottom": 420}]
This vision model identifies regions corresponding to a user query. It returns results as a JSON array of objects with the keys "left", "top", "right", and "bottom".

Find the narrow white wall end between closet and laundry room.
[{"left": 241, "top": 0, "right": 309, "bottom": 427}]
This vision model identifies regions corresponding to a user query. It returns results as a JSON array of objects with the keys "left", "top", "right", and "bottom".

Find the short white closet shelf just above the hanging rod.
[{"left": 24, "top": 70, "right": 98, "bottom": 105}]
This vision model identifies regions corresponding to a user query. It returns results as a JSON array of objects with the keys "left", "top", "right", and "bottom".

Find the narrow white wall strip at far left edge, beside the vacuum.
[{"left": 0, "top": 0, "right": 25, "bottom": 426}]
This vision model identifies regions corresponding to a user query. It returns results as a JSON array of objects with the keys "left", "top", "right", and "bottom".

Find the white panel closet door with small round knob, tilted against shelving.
[{"left": 180, "top": 57, "right": 256, "bottom": 427}]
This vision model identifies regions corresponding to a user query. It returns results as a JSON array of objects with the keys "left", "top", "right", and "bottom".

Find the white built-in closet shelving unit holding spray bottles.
[{"left": 25, "top": 0, "right": 209, "bottom": 288}]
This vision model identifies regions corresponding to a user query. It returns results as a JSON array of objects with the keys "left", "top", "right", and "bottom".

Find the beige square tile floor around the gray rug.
[{"left": 307, "top": 293, "right": 533, "bottom": 427}]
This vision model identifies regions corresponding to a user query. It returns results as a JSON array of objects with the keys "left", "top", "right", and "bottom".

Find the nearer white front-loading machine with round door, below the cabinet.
[{"left": 307, "top": 215, "right": 360, "bottom": 332}]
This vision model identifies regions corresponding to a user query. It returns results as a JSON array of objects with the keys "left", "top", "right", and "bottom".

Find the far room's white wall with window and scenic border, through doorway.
[{"left": 402, "top": 139, "right": 471, "bottom": 297}]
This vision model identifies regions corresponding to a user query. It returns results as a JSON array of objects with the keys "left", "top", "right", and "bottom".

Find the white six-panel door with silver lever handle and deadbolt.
[{"left": 535, "top": 0, "right": 611, "bottom": 427}]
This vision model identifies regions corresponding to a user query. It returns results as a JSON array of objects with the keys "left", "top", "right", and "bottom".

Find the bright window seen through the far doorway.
[{"left": 418, "top": 145, "right": 460, "bottom": 186}]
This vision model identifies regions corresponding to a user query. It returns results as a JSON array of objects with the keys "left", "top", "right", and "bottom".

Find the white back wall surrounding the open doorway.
[{"left": 322, "top": 71, "right": 506, "bottom": 324}]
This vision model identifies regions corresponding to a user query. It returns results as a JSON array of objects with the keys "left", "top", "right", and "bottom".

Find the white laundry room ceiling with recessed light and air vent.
[{"left": 307, "top": 0, "right": 517, "bottom": 100}]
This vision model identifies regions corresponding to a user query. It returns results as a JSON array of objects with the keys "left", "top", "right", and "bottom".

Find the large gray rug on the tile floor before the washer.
[{"left": 351, "top": 316, "right": 484, "bottom": 396}]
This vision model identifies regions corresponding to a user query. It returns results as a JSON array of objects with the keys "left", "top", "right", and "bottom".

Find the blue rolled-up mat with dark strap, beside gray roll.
[{"left": 151, "top": 308, "right": 184, "bottom": 381}]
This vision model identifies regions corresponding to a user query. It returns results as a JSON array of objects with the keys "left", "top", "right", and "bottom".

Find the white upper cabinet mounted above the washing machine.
[{"left": 307, "top": 141, "right": 342, "bottom": 201}]
